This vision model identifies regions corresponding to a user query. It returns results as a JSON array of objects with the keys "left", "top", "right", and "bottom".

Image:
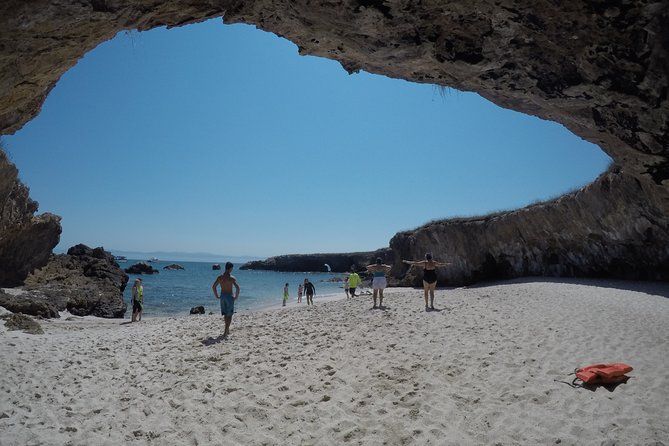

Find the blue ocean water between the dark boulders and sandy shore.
[{"left": 119, "top": 259, "right": 344, "bottom": 318}]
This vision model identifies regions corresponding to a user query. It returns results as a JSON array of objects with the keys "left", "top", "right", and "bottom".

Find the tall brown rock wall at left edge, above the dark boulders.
[{"left": 0, "top": 150, "right": 61, "bottom": 287}]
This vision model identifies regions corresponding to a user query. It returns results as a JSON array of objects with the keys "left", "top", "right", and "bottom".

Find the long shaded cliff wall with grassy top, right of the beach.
[{"left": 390, "top": 168, "right": 669, "bottom": 285}]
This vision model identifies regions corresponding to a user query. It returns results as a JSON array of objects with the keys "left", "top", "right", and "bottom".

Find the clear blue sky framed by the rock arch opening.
[{"left": 5, "top": 20, "right": 609, "bottom": 256}]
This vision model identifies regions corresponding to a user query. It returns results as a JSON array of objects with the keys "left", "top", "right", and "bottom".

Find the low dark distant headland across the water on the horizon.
[{"left": 240, "top": 249, "right": 393, "bottom": 273}]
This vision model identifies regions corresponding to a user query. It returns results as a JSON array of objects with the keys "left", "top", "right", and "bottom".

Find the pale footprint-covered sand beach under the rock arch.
[{"left": 0, "top": 279, "right": 669, "bottom": 446}]
